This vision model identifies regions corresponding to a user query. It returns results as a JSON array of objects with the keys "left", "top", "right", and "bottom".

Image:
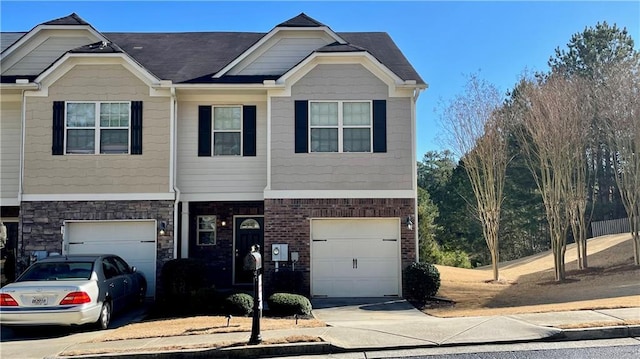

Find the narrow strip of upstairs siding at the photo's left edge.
[{"left": 0, "top": 101, "right": 22, "bottom": 200}]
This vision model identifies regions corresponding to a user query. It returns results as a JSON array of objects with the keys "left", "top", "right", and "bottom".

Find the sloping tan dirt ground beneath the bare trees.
[{"left": 424, "top": 234, "right": 640, "bottom": 317}]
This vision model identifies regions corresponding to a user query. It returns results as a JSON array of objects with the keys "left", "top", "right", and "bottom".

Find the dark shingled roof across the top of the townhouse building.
[{"left": 0, "top": 13, "right": 424, "bottom": 84}]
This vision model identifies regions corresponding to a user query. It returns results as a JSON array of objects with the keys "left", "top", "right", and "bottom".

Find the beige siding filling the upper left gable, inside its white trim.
[{"left": 2, "top": 33, "right": 95, "bottom": 76}]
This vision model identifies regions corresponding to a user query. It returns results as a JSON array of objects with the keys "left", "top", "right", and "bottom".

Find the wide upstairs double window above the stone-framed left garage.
[{"left": 65, "top": 102, "right": 131, "bottom": 154}]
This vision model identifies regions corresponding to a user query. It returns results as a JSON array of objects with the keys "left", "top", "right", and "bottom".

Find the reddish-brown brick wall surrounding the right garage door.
[{"left": 263, "top": 198, "right": 417, "bottom": 296}]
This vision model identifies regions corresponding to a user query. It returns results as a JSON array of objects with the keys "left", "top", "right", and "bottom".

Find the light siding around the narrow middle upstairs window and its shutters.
[{"left": 177, "top": 100, "right": 267, "bottom": 196}]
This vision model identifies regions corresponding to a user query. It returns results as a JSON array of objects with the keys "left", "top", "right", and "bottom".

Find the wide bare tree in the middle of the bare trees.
[{"left": 518, "top": 74, "right": 589, "bottom": 281}]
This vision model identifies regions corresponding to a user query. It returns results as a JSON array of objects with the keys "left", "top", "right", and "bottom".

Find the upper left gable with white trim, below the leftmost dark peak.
[{"left": 2, "top": 29, "right": 101, "bottom": 76}]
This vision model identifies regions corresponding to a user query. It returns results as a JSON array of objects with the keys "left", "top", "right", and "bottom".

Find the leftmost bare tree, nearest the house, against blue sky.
[{"left": 441, "top": 75, "right": 509, "bottom": 281}]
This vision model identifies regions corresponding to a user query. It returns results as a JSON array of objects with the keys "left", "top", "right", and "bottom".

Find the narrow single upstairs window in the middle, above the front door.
[{"left": 213, "top": 106, "right": 242, "bottom": 156}]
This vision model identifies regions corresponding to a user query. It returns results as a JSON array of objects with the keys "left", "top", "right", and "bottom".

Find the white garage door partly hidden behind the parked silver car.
[{"left": 65, "top": 221, "right": 156, "bottom": 297}]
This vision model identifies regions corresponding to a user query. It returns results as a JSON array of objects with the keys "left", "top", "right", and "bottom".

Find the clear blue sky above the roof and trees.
[{"left": 0, "top": 0, "right": 640, "bottom": 159}]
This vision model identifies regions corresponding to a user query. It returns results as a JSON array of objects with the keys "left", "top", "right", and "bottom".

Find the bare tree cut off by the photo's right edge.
[{"left": 598, "top": 60, "right": 640, "bottom": 265}]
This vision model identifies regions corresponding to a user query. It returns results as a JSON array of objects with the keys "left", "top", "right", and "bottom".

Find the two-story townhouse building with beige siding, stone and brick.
[{"left": 0, "top": 14, "right": 426, "bottom": 297}]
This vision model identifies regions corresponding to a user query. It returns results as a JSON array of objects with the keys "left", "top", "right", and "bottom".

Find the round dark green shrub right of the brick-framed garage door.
[{"left": 404, "top": 263, "right": 440, "bottom": 305}]
